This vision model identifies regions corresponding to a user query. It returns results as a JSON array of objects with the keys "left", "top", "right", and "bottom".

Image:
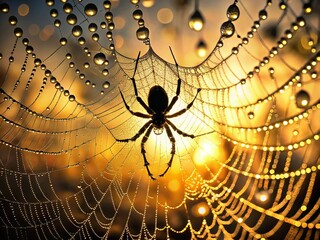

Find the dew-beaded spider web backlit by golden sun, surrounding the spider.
[{"left": 0, "top": 1, "right": 320, "bottom": 239}]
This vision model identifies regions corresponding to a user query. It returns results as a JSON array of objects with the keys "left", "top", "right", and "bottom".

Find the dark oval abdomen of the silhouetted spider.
[{"left": 148, "top": 85, "right": 169, "bottom": 113}]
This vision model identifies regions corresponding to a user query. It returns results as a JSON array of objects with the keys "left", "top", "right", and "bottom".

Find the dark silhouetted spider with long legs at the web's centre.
[{"left": 116, "top": 48, "right": 203, "bottom": 180}]
